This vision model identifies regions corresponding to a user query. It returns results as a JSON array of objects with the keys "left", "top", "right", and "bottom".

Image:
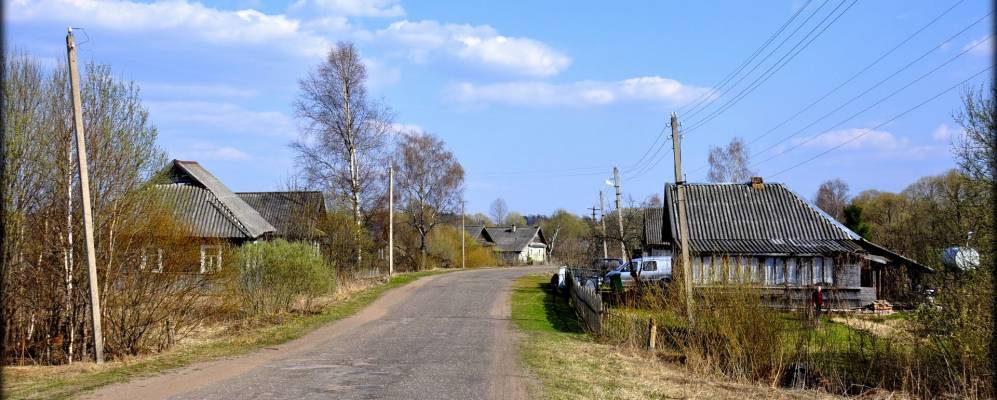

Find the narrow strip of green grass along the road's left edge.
[{"left": 3, "top": 271, "right": 447, "bottom": 399}]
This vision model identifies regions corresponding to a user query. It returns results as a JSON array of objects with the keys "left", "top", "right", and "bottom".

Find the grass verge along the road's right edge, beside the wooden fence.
[{"left": 510, "top": 275, "right": 844, "bottom": 400}]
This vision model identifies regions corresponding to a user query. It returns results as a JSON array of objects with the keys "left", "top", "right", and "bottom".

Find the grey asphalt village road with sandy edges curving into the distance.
[{"left": 83, "top": 267, "right": 553, "bottom": 400}]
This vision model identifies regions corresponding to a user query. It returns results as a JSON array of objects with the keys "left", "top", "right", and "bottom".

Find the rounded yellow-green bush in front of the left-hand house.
[{"left": 232, "top": 240, "right": 333, "bottom": 315}]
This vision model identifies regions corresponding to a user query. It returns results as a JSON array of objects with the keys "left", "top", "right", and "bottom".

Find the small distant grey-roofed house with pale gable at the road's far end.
[{"left": 464, "top": 225, "right": 549, "bottom": 264}]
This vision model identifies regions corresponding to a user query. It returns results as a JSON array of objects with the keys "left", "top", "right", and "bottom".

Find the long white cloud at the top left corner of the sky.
[{"left": 5, "top": 0, "right": 330, "bottom": 56}]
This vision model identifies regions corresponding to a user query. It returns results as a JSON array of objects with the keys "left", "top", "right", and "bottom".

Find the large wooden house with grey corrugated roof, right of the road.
[{"left": 647, "top": 178, "right": 933, "bottom": 309}]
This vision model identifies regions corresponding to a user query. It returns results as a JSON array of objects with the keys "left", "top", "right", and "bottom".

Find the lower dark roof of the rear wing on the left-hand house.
[{"left": 236, "top": 191, "right": 325, "bottom": 239}]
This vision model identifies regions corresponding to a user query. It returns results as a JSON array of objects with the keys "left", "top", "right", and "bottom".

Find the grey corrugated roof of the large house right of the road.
[{"left": 662, "top": 183, "right": 862, "bottom": 254}]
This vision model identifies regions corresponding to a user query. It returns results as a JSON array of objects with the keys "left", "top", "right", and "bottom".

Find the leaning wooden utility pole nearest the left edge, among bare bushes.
[{"left": 66, "top": 27, "right": 104, "bottom": 364}]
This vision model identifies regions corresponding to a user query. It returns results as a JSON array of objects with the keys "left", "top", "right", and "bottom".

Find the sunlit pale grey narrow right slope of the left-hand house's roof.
[{"left": 170, "top": 160, "right": 277, "bottom": 238}]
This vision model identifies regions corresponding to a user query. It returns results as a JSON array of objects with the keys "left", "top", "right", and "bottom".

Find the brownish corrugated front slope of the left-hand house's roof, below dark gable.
[{"left": 156, "top": 183, "right": 254, "bottom": 239}]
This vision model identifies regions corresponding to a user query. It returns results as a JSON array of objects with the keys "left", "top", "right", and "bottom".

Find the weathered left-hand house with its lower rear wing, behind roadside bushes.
[{"left": 152, "top": 160, "right": 325, "bottom": 273}]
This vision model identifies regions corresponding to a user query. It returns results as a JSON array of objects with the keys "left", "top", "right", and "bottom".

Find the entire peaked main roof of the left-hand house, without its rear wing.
[{"left": 156, "top": 160, "right": 277, "bottom": 239}]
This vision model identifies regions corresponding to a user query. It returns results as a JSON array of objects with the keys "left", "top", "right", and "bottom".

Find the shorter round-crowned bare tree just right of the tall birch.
[{"left": 396, "top": 133, "right": 464, "bottom": 268}]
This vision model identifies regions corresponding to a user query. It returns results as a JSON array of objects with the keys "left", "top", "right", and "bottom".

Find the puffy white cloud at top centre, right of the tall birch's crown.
[{"left": 372, "top": 20, "right": 571, "bottom": 77}]
